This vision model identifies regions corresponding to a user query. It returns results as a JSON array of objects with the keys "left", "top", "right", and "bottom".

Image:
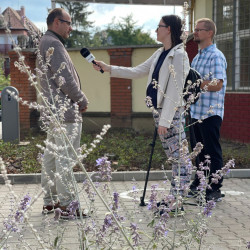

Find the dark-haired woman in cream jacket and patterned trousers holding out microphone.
[{"left": 93, "top": 15, "right": 192, "bottom": 215}]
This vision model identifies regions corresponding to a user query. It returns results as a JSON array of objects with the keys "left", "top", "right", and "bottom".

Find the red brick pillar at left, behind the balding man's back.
[{"left": 9, "top": 50, "right": 36, "bottom": 139}]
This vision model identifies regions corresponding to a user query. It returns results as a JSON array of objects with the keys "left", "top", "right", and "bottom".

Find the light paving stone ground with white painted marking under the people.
[{"left": 0, "top": 178, "right": 250, "bottom": 250}]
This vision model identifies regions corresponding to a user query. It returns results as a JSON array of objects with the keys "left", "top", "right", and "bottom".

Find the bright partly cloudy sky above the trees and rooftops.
[{"left": 0, "top": 0, "right": 186, "bottom": 39}]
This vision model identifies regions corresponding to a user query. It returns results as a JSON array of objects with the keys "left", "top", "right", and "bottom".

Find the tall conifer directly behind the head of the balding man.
[{"left": 61, "top": 2, "right": 93, "bottom": 48}]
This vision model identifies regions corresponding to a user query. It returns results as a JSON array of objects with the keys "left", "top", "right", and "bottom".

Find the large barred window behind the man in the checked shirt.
[{"left": 214, "top": 0, "right": 250, "bottom": 91}]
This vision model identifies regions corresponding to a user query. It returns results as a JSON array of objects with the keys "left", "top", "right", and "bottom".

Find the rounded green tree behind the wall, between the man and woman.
[{"left": 106, "top": 14, "right": 156, "bottom": 45}]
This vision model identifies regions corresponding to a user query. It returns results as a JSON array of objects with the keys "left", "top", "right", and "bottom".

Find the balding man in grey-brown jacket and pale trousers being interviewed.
[{"left": 38, "top": 8, "right": 88, "bottom": 217}]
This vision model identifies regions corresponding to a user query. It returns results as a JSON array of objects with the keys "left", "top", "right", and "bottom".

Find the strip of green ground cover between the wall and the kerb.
[{"left": 0, "top": 129, "right": 250, "bottom": 173}]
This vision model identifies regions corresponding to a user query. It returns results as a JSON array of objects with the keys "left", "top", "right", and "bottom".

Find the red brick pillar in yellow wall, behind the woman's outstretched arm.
[{"left": 108, "top": 48, "right": 133, "bottom": 128}]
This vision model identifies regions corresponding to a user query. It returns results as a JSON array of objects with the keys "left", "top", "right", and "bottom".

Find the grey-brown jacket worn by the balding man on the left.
[{"left": 39, "top": 31, "right": 88, "bottom": 122}]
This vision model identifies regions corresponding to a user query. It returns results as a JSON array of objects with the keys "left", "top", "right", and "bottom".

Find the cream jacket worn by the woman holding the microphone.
[{"left": 110, "top": 44, "right": 190, "bottom": 128}]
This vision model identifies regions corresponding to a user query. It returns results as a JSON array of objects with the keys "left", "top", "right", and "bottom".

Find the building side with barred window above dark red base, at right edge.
[{"left": 213, "top": 0, "right": 250, "bottom": 143}]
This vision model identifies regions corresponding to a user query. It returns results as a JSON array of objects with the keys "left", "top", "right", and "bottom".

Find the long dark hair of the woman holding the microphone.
[{"left": 162, "top": 15, "right": 182, "bottom": 47}]
